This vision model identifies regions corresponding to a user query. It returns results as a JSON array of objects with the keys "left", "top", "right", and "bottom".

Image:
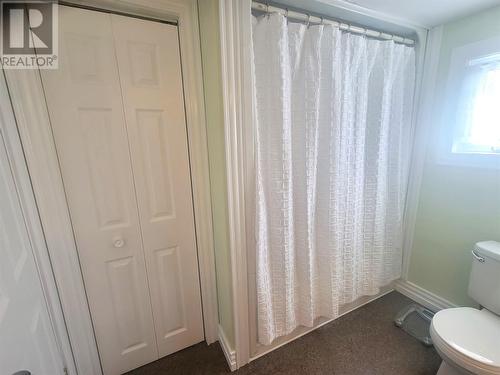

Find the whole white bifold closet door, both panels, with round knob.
[{"left": 42, "top": 6, "right": 204, "bottom": 375}]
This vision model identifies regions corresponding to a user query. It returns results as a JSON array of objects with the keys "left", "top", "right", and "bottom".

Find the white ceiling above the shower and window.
[{"left": 319, "top": 0, "right": 500, "bottom": 28}]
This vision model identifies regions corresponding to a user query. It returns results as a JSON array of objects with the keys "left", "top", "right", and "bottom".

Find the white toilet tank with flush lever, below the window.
[{"left": 469, "top": 241, "right": 500, "bottom": 315}]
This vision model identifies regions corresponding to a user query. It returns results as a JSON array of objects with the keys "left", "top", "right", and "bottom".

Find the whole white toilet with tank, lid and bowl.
[{"left": 430, "top": 241, "right": 500, "bottom": 375}]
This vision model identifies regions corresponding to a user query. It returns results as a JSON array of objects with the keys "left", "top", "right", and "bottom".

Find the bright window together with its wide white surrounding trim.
[{"left": 440, "top": 36, "right": 500, "bottom": 169}]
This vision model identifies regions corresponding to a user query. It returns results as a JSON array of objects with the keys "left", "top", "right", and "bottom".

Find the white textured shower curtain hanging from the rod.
[{"left": 253, "top": 14, "right": 415, "bottom": 345}]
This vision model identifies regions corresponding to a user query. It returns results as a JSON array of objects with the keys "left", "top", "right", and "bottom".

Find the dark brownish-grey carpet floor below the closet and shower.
[{"left": 128, "top": 292, "right": 441, "bottom": 375}]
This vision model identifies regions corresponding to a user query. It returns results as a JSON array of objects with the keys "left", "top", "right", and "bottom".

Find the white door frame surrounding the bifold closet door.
[{"left": 6, "top": 0, "right": 218, "bottom": 375}]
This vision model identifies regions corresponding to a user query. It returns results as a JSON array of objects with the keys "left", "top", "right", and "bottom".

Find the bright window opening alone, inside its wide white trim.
[{"left": 452, "top": 53, "right": 500, "bottom": 154}]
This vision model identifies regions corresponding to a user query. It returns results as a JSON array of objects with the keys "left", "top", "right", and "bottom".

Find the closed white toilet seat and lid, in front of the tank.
[{"left": 431, "top": 307, "right": 500, "bottom": 375}]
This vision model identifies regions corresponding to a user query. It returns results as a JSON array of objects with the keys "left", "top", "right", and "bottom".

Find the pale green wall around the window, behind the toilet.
[{"left": 408, "top": 7, "right": 500, "bottom": 305}]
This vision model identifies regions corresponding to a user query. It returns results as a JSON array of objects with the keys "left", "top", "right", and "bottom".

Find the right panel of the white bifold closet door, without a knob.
[{"left": 112, "top": 15, "right": 204, "bottom": 356}]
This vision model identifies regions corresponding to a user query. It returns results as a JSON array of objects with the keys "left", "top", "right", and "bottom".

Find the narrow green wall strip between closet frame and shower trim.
[{"left": 198, "top": 0, "right": 234, "bottom": 347}]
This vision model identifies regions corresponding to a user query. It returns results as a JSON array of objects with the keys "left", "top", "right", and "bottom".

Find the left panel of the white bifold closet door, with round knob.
[{"left": 41, "top": 6, "right": 158, "bottom": 374}]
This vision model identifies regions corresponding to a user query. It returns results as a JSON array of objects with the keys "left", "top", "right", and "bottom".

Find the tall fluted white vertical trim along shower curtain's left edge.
[{"left": 219, "top": 0, "right": 253, "bottom": 368}]
